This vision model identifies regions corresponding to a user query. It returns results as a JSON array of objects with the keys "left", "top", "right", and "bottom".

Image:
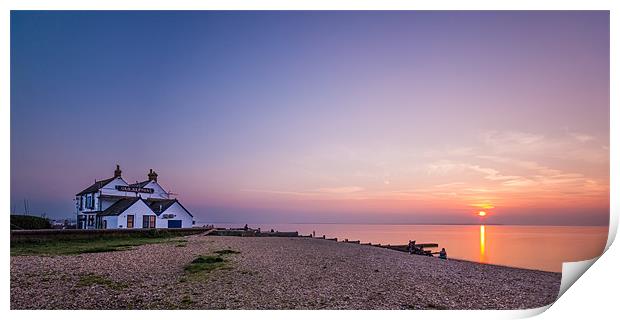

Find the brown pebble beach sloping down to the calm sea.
[{"left": 11, "top": 235, "right": 561, "bottom": 309}]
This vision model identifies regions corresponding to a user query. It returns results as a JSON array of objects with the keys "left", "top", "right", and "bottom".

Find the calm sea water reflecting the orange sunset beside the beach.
[{"left": 202, "top": 223, "right": 608, "bottom": 272}]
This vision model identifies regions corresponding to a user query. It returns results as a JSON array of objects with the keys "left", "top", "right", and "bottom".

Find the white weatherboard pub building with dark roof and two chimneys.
[{"left": 75, "top": 165, "right": 194, "bottom": 229}]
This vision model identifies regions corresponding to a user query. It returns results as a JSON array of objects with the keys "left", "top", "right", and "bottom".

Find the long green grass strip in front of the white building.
[{"left": 11, "top": 234, "right": 187, "bottom": 256}]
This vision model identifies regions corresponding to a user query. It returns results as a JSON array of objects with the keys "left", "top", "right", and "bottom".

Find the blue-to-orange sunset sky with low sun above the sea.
[{"left": 10, "top": 11, "right": 610, "bottom": 225}]
